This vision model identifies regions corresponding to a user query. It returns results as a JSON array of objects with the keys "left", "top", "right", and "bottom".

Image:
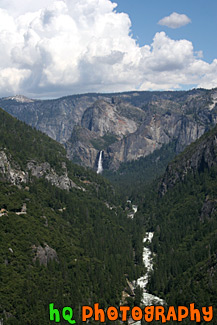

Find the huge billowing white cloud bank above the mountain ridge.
[{"left": 0, "top": 0, "right": 217, "bottom": 97}]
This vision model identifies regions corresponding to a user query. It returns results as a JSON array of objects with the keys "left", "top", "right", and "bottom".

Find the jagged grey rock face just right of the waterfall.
[{"left": 107, "top": 114, "right": 206, "bottom": 169}]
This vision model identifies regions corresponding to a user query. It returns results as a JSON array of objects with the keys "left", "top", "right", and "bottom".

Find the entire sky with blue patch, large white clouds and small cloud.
[{"left": 0, "top": 0, "right": 217, "bottom": 98}]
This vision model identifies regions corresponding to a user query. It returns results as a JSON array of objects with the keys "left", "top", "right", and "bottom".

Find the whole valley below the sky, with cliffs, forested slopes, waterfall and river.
[{"left": 0, "top": 89, "right": 217, "bottom": 325}]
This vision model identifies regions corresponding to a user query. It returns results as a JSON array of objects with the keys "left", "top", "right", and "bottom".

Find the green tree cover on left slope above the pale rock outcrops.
[{"left": 0, "top": 109, "right": 66, "bottom": 171}]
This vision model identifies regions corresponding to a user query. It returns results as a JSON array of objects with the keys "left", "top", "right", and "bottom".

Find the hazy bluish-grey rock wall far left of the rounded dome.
[{"left": 0, "top": 95, "right": 100, "bottom": 143}]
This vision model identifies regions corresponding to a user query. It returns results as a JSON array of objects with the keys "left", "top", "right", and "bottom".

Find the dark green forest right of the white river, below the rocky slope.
[{"left": 140, "top": 167, "right": 217, "bottom": 324}]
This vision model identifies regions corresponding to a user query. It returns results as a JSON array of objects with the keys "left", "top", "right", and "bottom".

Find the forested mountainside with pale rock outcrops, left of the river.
[{"left": 0, "top": 108, "right": 143, "bottom": 325}]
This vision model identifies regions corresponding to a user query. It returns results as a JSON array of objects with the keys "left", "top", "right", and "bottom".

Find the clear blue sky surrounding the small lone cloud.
[{"left": 113, "top": 0, "right": 217, "bottom": 63}]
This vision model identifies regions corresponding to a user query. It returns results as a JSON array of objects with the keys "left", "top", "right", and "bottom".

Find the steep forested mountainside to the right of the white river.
[{"left": 136, "top": 122, "right": 217, "bottom": 324}]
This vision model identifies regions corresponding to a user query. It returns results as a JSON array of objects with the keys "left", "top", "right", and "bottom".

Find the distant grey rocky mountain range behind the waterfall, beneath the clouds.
[{"left": 0, "top": 89, "right": 217, "bottom": 170}]
